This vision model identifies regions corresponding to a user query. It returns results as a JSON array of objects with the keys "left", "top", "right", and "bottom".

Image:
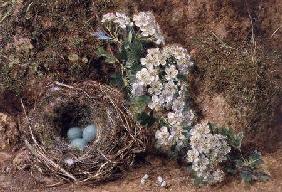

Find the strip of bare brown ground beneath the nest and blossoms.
[{"left": 0, "top": 146, "right": 282, "bottom": 192}]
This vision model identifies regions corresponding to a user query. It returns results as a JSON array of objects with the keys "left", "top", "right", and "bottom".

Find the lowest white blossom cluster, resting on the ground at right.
[{"left": 187, "top": 122, "right": 231, "bottom": 184}]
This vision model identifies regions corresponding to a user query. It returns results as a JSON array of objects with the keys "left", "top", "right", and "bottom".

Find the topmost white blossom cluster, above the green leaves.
[{"left": 101, "top": 11, "right": 165, "bottom": 45}]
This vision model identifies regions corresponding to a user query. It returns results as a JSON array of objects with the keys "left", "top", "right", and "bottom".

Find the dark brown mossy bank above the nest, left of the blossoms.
[{"left": 0, "top": 0, "right": 120, "bottom": 96}]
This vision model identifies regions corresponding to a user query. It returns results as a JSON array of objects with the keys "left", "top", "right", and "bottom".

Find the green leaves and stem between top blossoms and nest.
[{"left": 96, "top": 27, "right": 155, "bottom": 126}]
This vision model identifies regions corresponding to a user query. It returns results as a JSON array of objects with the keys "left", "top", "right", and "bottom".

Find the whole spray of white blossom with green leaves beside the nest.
[{"left": 98, "top": 12, "right": 265, "bottom": 187}]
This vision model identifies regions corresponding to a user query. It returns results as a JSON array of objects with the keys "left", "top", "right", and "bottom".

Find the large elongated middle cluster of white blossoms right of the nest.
[{"left": 132, "top": 45, "right": 194, "bottom": 148}]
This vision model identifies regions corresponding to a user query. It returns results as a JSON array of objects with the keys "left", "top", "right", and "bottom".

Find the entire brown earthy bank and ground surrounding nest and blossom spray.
[{"left": 0, "top": 0, "right": 282, "bottom": 192}]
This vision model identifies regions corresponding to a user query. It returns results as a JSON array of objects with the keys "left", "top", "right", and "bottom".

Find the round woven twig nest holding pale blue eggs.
[{"left": 22, "top": 81, "right": 144, "bottom": 183}]
